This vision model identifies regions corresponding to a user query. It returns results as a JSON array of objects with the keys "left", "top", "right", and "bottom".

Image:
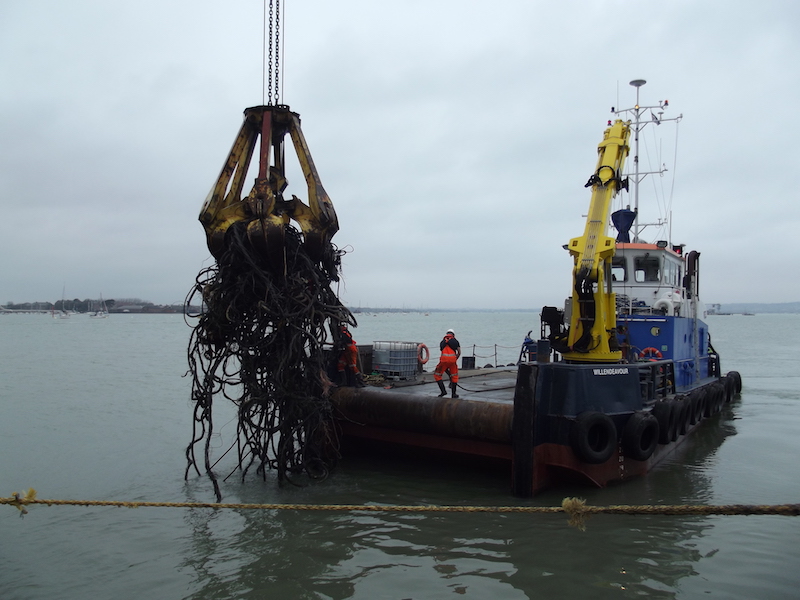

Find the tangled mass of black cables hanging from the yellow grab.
[{"left": 186, "top": 222, "right": 356, "bottom": 501}]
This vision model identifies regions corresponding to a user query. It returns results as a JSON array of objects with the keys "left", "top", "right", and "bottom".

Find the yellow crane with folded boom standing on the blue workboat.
[{"left": 563, "top": 119, "right": 630, "bottom": 362}]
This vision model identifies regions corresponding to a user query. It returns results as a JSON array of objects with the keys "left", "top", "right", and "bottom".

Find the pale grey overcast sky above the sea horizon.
[{"left": 0, "top": 0, "right": 800, "bottom": 309}]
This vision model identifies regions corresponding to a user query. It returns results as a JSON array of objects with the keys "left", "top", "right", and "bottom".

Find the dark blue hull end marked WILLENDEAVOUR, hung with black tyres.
[{"left": 512, "top": 361, "right": 741, "bottom": 496}]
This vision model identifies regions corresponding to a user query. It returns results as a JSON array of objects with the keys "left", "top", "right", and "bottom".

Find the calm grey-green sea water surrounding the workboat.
[{"left": 0, "top": 313, "right": 800, "bottom": 600}]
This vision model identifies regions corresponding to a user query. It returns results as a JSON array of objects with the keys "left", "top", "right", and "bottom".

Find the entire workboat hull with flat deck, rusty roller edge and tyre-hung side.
[{"left": 333, "top": 360, "right": 741, "bottom": 497}]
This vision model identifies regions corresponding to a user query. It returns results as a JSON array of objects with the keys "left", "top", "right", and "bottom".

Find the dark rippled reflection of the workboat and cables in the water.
[{"left": 185, "top": 405, "right": 736, "bottom": 599}]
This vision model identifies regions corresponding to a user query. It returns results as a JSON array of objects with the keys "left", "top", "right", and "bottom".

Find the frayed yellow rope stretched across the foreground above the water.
[{"left": 0, "top": 488, "right": 800, "bottom": 531}]
